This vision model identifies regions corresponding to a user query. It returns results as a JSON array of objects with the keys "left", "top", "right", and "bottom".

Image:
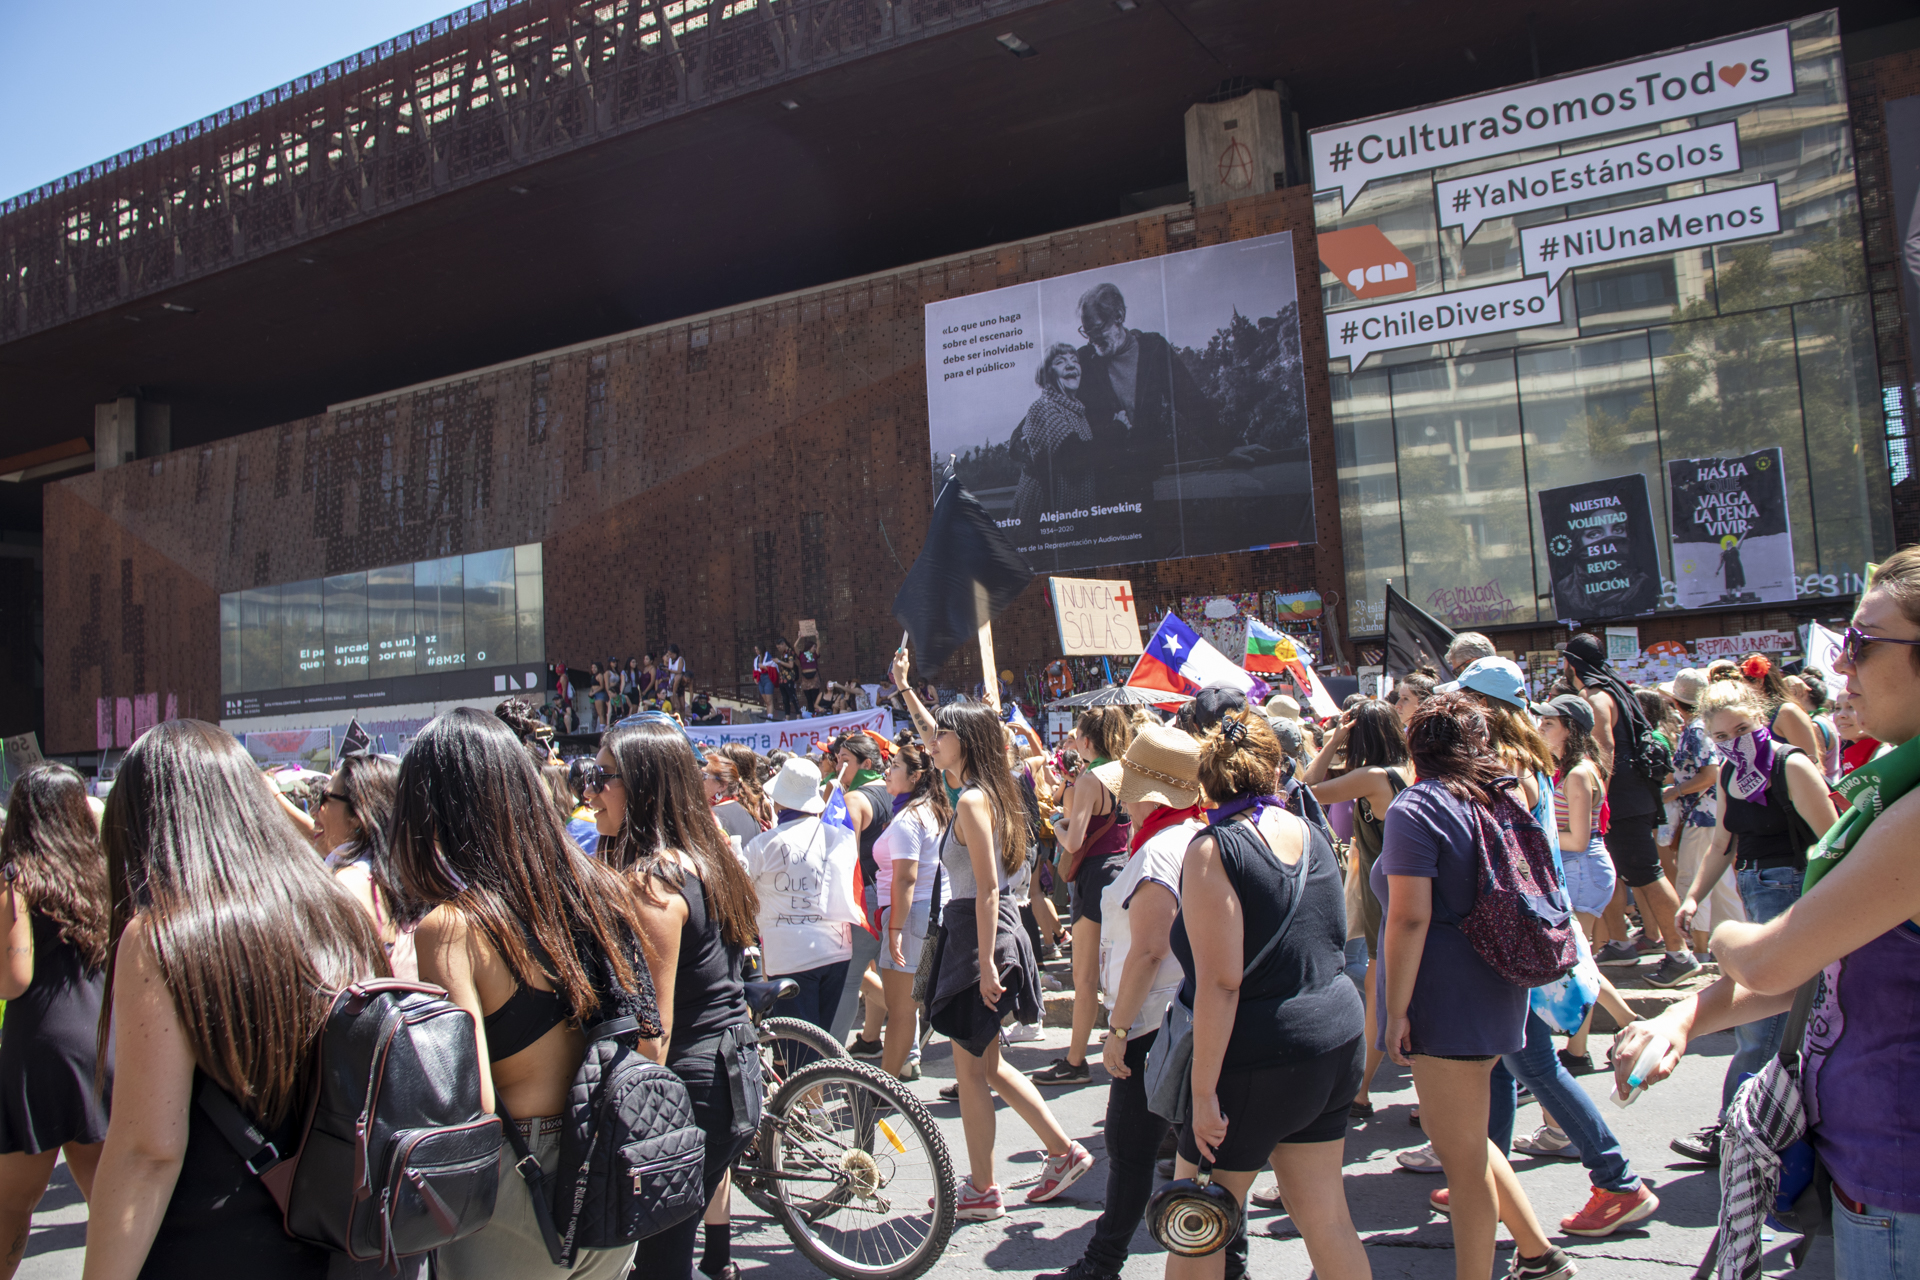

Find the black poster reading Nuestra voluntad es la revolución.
[{"left": 1540, "top": 472, "right": 1661, "bottom": 622}]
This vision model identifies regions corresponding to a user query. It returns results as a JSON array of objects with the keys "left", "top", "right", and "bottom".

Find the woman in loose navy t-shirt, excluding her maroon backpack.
[{"left": 1373, "top": 693, "right": 1574, "bottom": 1280}]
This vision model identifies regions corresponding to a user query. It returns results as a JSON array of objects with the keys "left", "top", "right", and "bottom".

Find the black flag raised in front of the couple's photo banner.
[{"left": 893, "top": 474, "right": 1033, "bottom": 679}]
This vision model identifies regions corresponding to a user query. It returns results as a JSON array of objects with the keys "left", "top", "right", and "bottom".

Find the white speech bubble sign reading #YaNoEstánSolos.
[{"left": 1434, "top": 121, "right": 1740, "bottom": 240}]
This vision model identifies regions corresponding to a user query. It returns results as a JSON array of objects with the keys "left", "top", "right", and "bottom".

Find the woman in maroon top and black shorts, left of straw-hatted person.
[{"left": 1033, "top": 706, "right": 1133, "bottom": 1084}]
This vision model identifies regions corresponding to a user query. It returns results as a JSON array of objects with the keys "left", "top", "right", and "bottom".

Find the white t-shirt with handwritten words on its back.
[{"left": 745, "top": 818, "right": 860, "bottom": 977}]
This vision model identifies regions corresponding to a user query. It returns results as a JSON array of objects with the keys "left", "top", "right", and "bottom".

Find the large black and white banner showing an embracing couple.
[{"left": 925, "top": 232, "right": 1315, "bottom": 572}]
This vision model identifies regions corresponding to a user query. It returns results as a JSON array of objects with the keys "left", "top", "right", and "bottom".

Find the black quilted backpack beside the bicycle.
[{"left": 499, "top": 1017, "right": 707, "bottom": 1267}]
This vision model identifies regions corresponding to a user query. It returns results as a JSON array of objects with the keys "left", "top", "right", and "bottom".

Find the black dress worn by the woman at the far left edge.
[{"left": 0, "top": 912, "right": 113, "bottom": 1153}]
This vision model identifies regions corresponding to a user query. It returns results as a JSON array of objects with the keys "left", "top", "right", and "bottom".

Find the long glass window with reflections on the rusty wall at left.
[{"left": 221, "top": 543, "right": 545, "bottom": 695}]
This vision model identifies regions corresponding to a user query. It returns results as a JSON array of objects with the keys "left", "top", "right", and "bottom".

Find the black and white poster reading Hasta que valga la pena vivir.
[{"left": 1667, "top": 447, "right": 1799, "bottom": 608}]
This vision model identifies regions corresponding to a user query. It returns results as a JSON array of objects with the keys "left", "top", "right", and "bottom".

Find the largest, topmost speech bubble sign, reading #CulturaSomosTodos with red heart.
[{"left": 1308, "top": 25, "right": 1793, "bottom": 209}]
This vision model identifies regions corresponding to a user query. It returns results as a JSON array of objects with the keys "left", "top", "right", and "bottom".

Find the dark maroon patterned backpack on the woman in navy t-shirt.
[{"left": 1459, "top": 789, "right": 1578, "bottom": 986}]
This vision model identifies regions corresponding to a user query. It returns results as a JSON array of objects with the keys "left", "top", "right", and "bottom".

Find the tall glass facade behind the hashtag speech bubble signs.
[{"left": 1315, "top": 13, "right": 1893, "bottom": 633}]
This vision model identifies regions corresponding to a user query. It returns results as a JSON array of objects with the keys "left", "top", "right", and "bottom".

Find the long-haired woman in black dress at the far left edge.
[{"left": 0, "top": 764, "right": 113, "bottom": 1276}]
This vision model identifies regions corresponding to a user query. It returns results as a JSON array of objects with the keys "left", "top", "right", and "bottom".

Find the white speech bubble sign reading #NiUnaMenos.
[{"left": 1521, "top": 182, "right": 1780, "bottom": 284}]
